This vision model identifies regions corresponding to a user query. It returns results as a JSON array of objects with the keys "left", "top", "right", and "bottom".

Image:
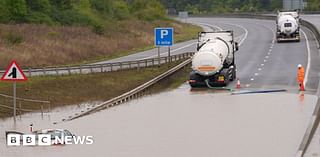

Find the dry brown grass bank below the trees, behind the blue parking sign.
[{"left": 0, "top": 19, "right": 201, "bottom": 69}]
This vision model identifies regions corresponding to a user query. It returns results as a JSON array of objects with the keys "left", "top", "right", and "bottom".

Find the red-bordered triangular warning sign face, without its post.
[{"left": 1, "top": 61, "right": 28, "bottom": 81}]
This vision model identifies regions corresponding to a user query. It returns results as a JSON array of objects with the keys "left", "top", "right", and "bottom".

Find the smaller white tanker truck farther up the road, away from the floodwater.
[{"left": 276, "top": 11, "right": 300, "bottom": 42}]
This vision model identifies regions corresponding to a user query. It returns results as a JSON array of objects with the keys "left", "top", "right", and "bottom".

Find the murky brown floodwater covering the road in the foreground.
[{"left": 0, "top": 84, "right": 317, "bottom": 157}]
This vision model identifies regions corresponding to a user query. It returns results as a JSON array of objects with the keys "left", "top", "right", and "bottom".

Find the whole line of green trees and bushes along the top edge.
[{"left": 0, "top": 0, "right": 320, "bottom": 26}]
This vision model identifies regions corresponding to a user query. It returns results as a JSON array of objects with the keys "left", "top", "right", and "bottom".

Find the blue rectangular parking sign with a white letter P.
[{"left": 154, "top": 28, "right": 173, "bottom": 46}]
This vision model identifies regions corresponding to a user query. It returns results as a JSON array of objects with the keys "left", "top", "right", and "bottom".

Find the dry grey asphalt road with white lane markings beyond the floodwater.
[{"left": 95, "top": 18, "right": 320, "bottom": 93}]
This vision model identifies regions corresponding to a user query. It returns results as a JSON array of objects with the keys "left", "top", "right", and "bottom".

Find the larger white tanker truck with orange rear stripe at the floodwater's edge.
[{"left": 189, "top": 31, "right": 238, "bottom": 87}]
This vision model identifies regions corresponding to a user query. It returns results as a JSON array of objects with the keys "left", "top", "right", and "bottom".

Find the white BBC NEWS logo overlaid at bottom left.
[{"left": 7, "top": 134, "right": 94, "bottom": 146}]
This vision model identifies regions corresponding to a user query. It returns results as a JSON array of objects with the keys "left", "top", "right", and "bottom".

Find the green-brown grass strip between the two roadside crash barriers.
[{"left": 0, "top": 62, "right": 187, "bottom": 117}]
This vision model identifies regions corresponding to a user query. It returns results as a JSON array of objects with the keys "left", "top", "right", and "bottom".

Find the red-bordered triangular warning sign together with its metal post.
[{"left": 1, "top": 61, "right": 28, "bottom": 122}]
